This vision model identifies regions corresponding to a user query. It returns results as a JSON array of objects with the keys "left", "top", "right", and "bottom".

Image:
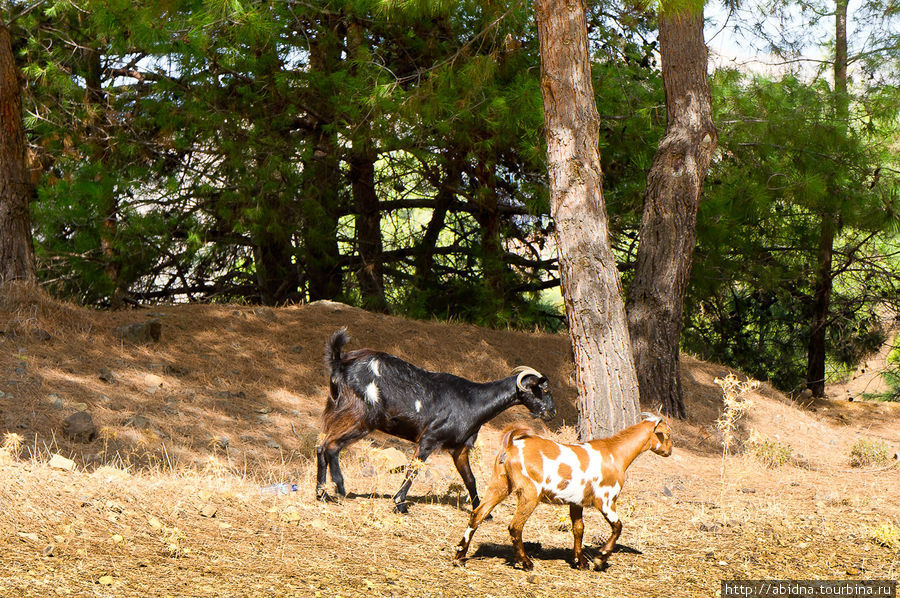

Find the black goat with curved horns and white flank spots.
[{"left": 316, "top": 328, "right": 556, "bottom": 513}]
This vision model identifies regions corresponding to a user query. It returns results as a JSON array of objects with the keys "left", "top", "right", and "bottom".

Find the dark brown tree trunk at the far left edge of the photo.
[{"left": 0, "top": 22, "right": 37, "bottom": 284}]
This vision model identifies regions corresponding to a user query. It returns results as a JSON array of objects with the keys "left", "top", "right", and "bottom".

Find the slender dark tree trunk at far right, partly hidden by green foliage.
[{"left": 806, "top": 0, "right": 849, "bottom": 397}]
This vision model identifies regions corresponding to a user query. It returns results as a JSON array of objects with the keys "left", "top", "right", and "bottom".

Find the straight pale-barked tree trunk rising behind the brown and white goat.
[{"left": 534, "top": 0, "right": 639, "bottom": 440}]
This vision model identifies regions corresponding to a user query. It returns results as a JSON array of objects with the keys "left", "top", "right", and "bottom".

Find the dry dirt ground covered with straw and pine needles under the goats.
[{"left": 0, "top": 287, "right": 900, "bottom": 598}]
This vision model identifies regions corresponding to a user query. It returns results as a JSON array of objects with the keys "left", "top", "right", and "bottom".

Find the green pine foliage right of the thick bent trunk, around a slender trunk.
[{"left": 683, "top": 72, "right": 898, "bottom": 389}]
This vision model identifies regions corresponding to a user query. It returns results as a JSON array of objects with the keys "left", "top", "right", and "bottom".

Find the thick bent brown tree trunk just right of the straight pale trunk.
[{"left": 628, "top": 8, "right": 717, "bottom": 417}]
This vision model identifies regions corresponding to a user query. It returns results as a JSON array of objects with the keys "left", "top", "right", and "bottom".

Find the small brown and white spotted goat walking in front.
[{"left": 455, "top": 413, "right": 672, "bottom": 570}]
